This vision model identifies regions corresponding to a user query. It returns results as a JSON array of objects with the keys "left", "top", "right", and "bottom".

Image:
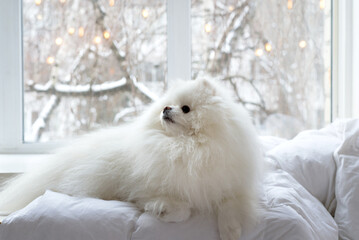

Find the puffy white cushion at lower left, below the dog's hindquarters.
[{"left": 0, "top": 191, "right": 140, "bottom": 240}]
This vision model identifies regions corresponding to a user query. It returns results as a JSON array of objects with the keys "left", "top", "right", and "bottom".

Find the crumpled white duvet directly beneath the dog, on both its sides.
[{"left": 0, "top": 169, "right": 338, "bottom": 240}]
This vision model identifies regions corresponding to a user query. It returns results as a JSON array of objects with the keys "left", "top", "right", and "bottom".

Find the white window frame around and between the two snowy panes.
[{"left": 0, "top": 0, "right": 359, "bottom": 159}]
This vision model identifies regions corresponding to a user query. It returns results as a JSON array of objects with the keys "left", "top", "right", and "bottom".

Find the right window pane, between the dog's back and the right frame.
[{"left": 192, "top": 0, "right": 331, "bottom": 138}]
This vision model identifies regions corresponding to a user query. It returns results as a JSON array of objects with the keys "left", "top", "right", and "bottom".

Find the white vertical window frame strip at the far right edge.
[{"left": 332, "top": 0, "right": 359, "bottom": 120}]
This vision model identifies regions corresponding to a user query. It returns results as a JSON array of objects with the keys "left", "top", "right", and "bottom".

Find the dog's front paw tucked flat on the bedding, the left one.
[{"left": 145, "top": 199, "right": 191, "bottom": 222}]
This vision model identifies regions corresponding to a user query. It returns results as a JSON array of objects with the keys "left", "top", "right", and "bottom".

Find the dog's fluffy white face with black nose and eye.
[{"left": 160, "top": 80, "right": 226, "bottom": 135}]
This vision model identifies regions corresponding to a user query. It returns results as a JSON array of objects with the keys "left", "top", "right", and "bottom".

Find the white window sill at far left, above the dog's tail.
[{"left": 0, "top": 154, "right": 49, "bottom": 174}]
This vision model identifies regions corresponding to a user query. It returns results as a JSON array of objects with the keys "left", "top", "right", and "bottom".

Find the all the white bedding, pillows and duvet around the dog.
[{"left": 0, "top": 120, "right": 359, "bottom": 240}]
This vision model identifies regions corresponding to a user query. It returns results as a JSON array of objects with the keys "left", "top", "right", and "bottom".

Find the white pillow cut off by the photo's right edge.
[{"left": 334, "top": 119, "right": 359, "bottom": 239}]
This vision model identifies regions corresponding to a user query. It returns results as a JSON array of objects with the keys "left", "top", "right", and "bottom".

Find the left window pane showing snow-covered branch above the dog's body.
[{"left": 23, "top": 0, "right": 167, "bottom": 142}]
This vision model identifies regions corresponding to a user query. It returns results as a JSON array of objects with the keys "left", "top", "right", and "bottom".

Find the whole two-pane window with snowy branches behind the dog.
[{"left": 0, "top": 0, "right": 355, "bottom": 152}]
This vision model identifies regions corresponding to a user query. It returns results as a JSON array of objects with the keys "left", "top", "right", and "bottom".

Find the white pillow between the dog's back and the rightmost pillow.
[{"left": 267, "top": 122, "right": 343, "bottom": 213}]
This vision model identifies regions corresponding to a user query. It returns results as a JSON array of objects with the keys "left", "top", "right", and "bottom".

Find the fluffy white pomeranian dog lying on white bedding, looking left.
[{"left": 0, "top": 80, "right": 262, "bottom": 240}]
